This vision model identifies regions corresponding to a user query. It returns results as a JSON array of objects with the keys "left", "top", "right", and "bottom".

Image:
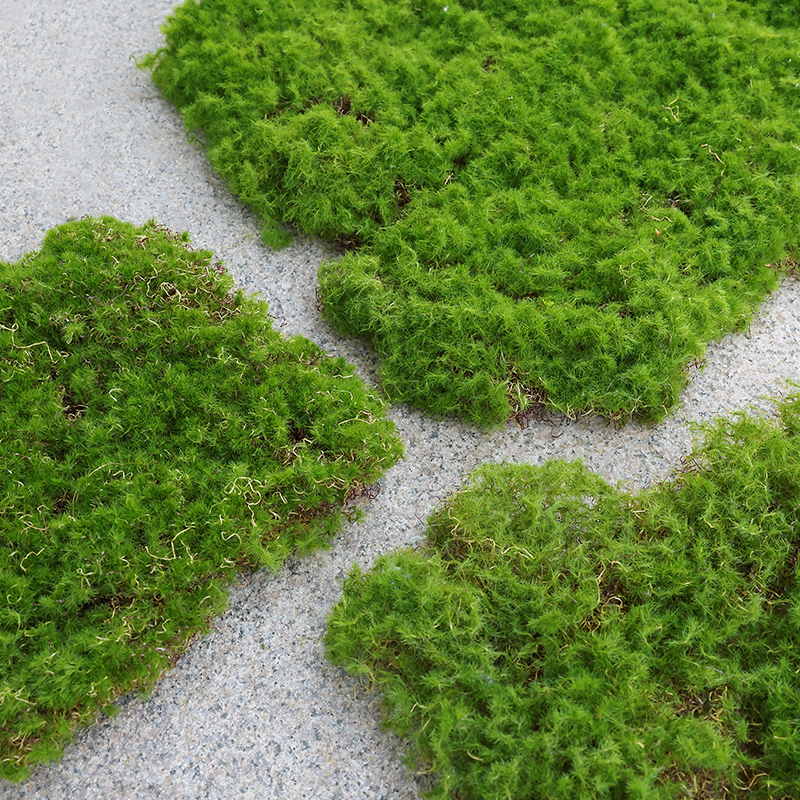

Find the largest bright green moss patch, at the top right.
[{"left": 144, "top": 0, "right": 800, "bottom": 425}]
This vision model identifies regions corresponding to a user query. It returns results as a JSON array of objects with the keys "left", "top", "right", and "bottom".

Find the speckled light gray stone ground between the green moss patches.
[{"left": 0, "top": 0, "right": 800, "bottom": 800}]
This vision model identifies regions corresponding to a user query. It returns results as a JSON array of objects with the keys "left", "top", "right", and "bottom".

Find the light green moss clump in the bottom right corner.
[{"left": 326, "top": 396, "right": 800, "bottom": 800}]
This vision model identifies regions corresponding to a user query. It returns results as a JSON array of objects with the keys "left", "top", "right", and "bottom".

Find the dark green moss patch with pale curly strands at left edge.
[{"left": 0, "top": 218, "right": 401, "bottom": 780}]
